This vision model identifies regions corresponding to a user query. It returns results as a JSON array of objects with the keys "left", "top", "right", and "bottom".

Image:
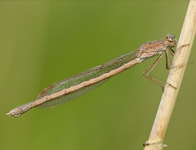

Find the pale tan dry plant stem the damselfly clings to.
[{"left": 144, "top": 0, "right": 196, "bottom": 150}]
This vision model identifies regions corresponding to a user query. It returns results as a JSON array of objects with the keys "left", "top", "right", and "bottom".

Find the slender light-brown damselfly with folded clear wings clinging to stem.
[{"left": 6, "top": 34, "right": 177, "bottom": 117}]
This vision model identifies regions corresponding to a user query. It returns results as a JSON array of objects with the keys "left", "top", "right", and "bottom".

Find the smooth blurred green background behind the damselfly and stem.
[{"left": 0, "top": 0, "right": 196, "bottom": 150}]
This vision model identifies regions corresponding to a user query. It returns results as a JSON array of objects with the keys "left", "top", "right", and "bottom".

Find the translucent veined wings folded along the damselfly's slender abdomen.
[{"left": 37, "top": 50, "right": 137, "bottom": 108}]
